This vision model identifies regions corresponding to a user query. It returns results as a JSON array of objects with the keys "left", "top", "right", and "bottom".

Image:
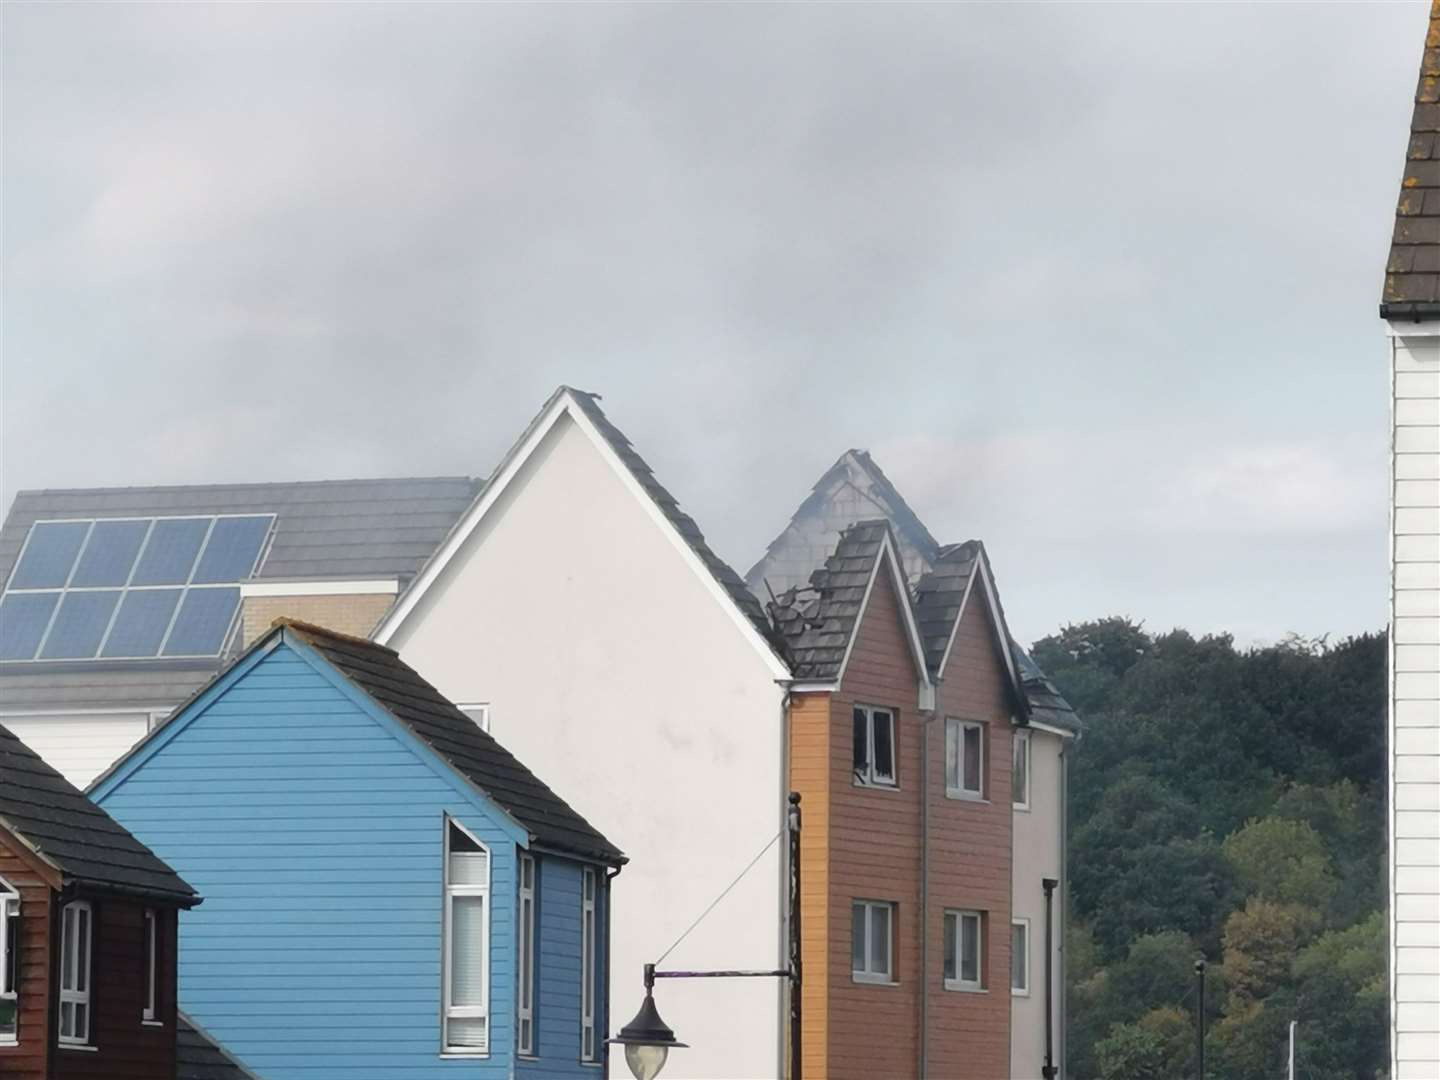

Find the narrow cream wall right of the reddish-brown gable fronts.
[{"left": 1009, "top": 729, "right": 1070, "bottom": 1080}]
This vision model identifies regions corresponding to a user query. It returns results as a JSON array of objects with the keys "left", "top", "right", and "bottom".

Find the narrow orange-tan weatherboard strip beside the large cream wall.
[{"left": 789, "top": 694, "right": 848, "bottom": 1077}]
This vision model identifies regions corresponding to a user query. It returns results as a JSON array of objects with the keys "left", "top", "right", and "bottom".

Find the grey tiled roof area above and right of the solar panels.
[{"left": 0, "top": 477, "right": 482, "bottom": 593}]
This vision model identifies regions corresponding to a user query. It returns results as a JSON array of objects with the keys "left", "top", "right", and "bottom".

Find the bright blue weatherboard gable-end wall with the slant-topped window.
[{"left": 94, "top": 644, "right": 603, "bottom": 1080}]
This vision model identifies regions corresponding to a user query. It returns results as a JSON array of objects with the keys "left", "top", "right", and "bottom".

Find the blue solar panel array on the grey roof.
[{"left": 0, "top": 514, "right": 275, "bottom": 661}]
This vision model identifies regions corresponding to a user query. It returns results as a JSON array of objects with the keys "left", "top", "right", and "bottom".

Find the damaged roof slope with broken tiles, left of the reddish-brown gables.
[{"left": 770, "top": 521, "right": 892, "bottom": 681}]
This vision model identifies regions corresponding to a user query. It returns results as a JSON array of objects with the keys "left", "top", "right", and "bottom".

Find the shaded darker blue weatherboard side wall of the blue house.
[{"left": 517, "top": 855, "right": 607, "bottom": 1080}]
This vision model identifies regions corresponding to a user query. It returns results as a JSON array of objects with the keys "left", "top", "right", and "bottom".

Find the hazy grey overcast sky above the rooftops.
[{"left": 0, "top": 3, "right": 1427, "bottom": 641}]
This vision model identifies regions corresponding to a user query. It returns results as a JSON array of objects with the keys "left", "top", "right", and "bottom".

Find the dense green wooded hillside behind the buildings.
[{"left": 1034, "top": 618, "right": 1388, "bottom": 1080}]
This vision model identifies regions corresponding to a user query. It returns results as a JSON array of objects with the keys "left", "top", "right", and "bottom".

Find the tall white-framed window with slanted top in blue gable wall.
[{"left": 444, "top": 818, "right": 490, "bottom": 1054}]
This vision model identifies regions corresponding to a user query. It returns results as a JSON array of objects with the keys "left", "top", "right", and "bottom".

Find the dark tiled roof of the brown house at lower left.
[{"left": 0, "top": 727, "right": 200, "bottom": 907}]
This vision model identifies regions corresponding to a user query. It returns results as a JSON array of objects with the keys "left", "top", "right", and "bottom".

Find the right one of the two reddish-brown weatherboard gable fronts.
[{"left": 929, "top": 590, "right": 1013, "bottom": 1080}]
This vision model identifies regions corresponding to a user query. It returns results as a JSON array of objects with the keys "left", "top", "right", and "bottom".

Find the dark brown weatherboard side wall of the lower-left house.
[{"left": 53, "top": 897, "right": 176, "bottom": 1080}]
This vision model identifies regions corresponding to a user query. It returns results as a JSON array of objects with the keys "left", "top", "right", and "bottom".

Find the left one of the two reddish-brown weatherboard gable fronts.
[{"left": 824, "top": 566, "right": 922, "bottom": 1080}]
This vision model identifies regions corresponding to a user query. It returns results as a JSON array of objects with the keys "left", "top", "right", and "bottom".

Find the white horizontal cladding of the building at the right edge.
[{"left": 1390, "top": 323, "right": 1440, "bottom": 1080}]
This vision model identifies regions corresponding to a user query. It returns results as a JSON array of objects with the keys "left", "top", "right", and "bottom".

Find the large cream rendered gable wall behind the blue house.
[{"left": 389, "top": 416, "right": 783, "bottom": 1080}]
